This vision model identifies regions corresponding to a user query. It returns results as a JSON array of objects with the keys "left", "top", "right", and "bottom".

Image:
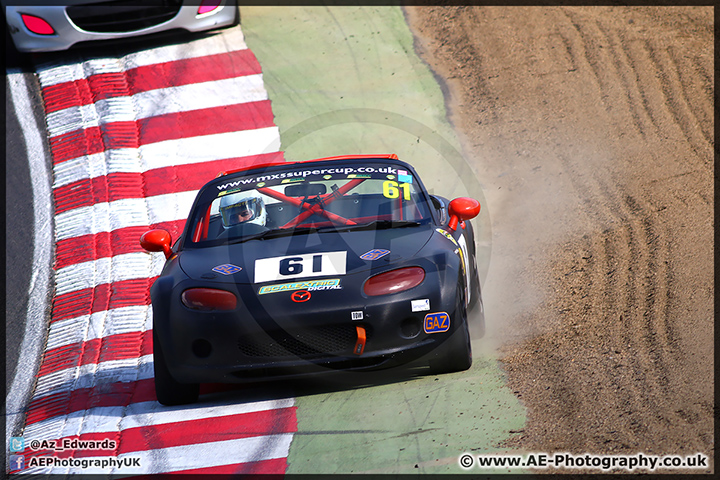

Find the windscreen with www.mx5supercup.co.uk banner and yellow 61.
[{"left": 184, "top": 163, "right": 431, "bottom": 247}]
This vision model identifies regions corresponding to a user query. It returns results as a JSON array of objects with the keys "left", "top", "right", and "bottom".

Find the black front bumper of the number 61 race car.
[{"left": 153, "top": 266, "right": 465, "bottom": 383}]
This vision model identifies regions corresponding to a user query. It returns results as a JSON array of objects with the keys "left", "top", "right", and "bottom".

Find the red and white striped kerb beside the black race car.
[{"left": 20, "top": 28, "right": 297, "bottom": 474}]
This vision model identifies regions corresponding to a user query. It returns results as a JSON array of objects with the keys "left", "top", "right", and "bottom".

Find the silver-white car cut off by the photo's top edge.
[{"left": 3, "top": 0, "right": 240, "bottom": 52}]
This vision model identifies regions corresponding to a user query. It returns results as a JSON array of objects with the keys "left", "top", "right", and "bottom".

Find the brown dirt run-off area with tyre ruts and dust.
[{"left": 405, "top": 6, "right": 714, "bottom": 473}]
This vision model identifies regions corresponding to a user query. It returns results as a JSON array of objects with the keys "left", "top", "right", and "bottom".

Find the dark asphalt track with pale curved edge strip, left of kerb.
[{"left": 5, "top": 69, "right": 53, "bottom": 452}]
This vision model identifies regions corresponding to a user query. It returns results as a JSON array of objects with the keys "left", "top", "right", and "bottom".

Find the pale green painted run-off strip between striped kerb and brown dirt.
[{"left": 8, "top": 7, "right": 524, "bottom": 473}]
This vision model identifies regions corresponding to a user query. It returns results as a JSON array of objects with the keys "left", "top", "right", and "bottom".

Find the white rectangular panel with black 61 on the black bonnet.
[{"left": 254, "top": 252, "right": 347, "bottom": 283}]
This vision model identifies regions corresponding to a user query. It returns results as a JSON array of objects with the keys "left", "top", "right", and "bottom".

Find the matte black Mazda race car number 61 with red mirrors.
[{"left": 141, "top": 155, "right": 484, "bottom": 405}]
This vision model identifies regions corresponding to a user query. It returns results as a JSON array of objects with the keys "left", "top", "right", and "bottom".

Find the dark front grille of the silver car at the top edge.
[{"left": 66, "top": 0, "right": 182, "bottom": 33}]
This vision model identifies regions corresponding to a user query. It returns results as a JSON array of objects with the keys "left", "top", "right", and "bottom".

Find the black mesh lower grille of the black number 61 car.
[{"left": 238, "top": 325, "right": 357, "bottom": 358}]
